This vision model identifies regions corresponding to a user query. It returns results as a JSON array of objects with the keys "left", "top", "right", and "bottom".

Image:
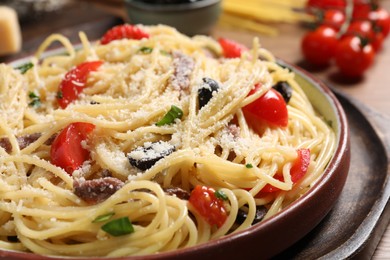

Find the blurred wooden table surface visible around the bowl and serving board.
[{"left": 0, "top": 0, "right": 390, "bottom": 259}]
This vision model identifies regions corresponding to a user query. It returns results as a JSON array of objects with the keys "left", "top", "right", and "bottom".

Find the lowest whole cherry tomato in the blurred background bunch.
[{"left": 335, "top": 36, "right": 375, "bottom": 77}]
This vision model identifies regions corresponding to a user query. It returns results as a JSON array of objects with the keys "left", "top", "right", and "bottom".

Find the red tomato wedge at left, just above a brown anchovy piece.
[{"left": 50, "top": 122, "right": 95, "bottom": 175}]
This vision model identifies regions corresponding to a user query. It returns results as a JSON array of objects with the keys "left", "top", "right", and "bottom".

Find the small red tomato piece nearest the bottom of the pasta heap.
[{"left": 188, "top": 185, "right": 227, "bottom": 227}]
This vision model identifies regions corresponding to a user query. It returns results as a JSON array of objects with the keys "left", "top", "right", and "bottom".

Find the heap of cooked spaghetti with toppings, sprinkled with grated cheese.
[{"left": 0, "top": 25, "right": 336, "bottom": 257}]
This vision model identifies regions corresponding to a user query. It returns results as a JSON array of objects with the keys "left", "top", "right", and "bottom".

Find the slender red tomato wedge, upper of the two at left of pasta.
[{"left": 57, "top": 61, "right": 103, "bottom": 108}]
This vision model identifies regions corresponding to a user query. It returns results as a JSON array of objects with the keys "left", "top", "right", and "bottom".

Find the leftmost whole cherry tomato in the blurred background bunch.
[{"left": 301, "top": 25, "right": 337, "bottom": 66}]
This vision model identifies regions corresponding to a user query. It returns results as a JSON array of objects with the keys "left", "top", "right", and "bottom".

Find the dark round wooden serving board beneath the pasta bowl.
[{"left": 275, "top": 90, "right": 390, "bottom": 259}]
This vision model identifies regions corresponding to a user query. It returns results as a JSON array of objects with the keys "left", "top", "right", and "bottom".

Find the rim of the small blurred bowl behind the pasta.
[{"left": 124, "top": 0, "right": 222, "bottom": 12}]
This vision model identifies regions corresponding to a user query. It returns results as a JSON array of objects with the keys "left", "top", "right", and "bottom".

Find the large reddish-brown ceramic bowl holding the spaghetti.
[{"left": 0, "top": 56, "right": 350, "bottom": 260}]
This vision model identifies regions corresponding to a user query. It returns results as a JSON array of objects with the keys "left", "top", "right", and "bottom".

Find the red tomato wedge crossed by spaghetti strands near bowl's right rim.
[{"left": 255, "top": 148, "right": 310, "bottom": 198}]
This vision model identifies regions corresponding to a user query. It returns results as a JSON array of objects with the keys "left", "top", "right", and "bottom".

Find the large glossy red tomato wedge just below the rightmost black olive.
[{"left": 242, "top": 84, "right": 288, "bottom": 134}]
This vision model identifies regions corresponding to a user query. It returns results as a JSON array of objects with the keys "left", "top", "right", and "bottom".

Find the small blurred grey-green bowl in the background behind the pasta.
[{"left": 125, "top": 0, "right": 221, "bottom": 36}]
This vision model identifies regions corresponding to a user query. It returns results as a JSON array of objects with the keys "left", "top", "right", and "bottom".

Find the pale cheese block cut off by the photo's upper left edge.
[{"left": 0, "top": 6, "right": 22, "bottom": 56}]
